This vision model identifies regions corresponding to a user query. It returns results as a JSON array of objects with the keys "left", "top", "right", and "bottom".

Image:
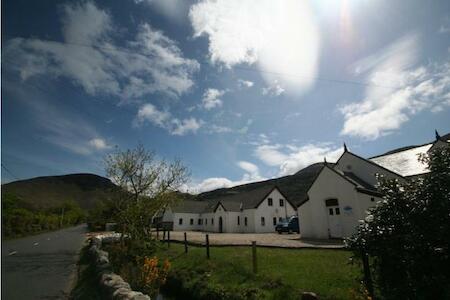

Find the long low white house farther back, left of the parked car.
[{"left": 162, "top": 186, "right": 296, "bottom": 233}]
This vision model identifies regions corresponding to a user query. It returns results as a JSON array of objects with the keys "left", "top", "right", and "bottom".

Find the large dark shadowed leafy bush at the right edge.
[{"left": 347, "top": 147, "right": 450, "bottom": 299}]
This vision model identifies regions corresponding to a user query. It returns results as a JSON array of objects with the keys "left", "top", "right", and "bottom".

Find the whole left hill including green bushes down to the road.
[{"left": 1, "top": 174, "right": 117, "bottom": 238}]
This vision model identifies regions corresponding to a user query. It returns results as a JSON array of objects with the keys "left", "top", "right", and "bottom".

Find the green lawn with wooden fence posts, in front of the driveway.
[{"left": 156, "top": 243, "right": 363, "bottom": 299}]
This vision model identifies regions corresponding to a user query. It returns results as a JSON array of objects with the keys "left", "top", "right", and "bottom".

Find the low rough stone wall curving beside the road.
[{"left": 89, "top": 236, "right": 150, "bottom": 300}]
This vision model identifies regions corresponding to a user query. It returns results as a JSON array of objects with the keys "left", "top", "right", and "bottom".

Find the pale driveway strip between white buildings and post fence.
[{"left": 156, "top": 231, "right": 343, "bottom": 249}]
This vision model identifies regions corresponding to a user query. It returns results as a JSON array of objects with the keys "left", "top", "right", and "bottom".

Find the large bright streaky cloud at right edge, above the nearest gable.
[{"left": 340, "top": 34, "right": 450, "bottom": 139}]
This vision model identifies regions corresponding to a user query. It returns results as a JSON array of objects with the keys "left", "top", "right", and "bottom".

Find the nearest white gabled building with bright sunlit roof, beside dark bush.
[{"left": 298, "top": 134, "right": 448, "bottom": 239}]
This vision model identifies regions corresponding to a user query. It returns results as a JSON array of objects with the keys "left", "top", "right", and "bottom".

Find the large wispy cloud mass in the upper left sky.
[{"left": 3, "top": 1, "right": 199, "bottom": 100}]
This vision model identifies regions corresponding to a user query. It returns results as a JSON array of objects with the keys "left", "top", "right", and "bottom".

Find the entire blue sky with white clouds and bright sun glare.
[{"left": 1, "top": 0, "right": 450, "bottom": 193}]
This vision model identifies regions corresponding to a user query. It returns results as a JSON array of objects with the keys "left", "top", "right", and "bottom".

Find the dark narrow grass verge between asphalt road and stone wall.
[{"left": 69, "top": 245, "right": 103, "bottom": 300}]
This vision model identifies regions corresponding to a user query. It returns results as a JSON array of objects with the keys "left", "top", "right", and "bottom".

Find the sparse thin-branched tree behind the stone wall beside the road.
[{"left": 105, "top": 144, "right": 188, "bottom": 251}]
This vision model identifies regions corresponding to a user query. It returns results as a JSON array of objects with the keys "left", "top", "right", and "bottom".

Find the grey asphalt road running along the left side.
[{"left": 1, "top": 225, "right": 87, "bottom": 300}]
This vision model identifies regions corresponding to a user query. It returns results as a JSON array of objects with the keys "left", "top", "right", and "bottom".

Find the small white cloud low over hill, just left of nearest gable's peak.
[{"left": 254, "top": 144, "right": 342, "bottom": 176}]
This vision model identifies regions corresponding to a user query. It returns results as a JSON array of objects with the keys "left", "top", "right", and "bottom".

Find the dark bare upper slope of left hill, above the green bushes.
[{"left": 2, "top": 174, "right": 117, "bottom": 211}]
